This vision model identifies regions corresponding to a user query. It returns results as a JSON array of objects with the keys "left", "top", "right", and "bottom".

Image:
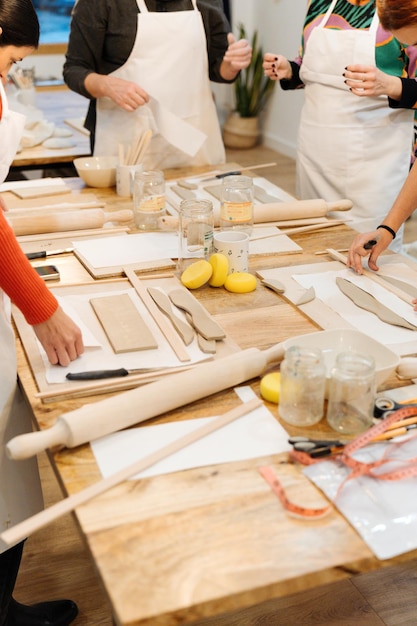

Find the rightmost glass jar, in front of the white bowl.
[{"left": 327, "top": 352, "right": 376, "bottom": 435}]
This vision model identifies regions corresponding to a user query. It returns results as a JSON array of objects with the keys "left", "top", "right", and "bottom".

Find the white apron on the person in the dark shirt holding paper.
[{"left": 94, "top": 0, "right": 225, "bottom": 169}]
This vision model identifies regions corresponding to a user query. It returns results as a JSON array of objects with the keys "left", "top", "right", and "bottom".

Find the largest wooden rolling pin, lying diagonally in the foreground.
[{"left": 6, "top": 343, "right": 284, "bottom": 459}]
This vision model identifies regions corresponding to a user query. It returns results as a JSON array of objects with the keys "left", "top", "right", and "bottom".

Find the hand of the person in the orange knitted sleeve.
[{"left": 33, "top": 307, "right": 84, "bottom": 366}]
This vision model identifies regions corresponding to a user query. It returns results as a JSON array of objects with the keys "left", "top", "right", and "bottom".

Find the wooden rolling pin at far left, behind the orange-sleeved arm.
[{"left": 7, "top": 209, "right": 133, "bottom": 237}]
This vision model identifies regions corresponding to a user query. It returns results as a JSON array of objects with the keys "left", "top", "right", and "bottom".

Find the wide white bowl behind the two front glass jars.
[{"left": 284, "top": 328, "right": 400, "bottom": 395}]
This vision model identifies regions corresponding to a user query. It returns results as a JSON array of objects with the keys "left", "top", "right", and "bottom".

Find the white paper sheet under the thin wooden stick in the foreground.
[{"left": 91, "top": 387, "right": 291, "bottom": 479}]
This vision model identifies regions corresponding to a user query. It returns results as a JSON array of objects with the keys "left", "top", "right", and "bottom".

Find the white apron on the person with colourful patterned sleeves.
[{"left": 297, "top": 0, "right": 414, "bottom": 250}]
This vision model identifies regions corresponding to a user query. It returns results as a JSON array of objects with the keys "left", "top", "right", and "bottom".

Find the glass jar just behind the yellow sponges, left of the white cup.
[{"left": 178, "top": 200, "right": 214, "bottom": 272}]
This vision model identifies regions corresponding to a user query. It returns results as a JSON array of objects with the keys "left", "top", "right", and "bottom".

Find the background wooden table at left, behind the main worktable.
[{"left": 11, "top": 87, "right": 91, "bottom": 172}]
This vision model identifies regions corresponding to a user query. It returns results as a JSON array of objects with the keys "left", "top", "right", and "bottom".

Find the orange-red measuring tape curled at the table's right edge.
[{"left": 259, "top": 407, "right": 417, "bottom": 519}]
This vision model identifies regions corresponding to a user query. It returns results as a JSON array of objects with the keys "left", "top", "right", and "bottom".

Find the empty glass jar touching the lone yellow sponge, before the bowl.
[{"left": 278, "top": 346, "right": 326, "bottom": 426}]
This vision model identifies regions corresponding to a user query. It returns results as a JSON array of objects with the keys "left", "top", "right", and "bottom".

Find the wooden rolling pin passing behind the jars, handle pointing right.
[{"left": 159, "top": 198, "right": 353, "bottom": 230}]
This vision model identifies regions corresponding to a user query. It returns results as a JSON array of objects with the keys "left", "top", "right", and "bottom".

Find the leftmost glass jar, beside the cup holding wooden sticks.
[{"left": 132, "top": 170, "right": 165, "bottom": 230}]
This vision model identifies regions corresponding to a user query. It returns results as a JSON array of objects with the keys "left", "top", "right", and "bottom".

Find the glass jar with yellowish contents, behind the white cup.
[{"left": 220, "top": 175, "right": 254, "bottom": 235}]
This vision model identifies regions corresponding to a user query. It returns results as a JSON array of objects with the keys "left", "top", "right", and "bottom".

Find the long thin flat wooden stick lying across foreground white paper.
[{"left": 0, "top": 398, "right": 262, "bottom": 545}]
